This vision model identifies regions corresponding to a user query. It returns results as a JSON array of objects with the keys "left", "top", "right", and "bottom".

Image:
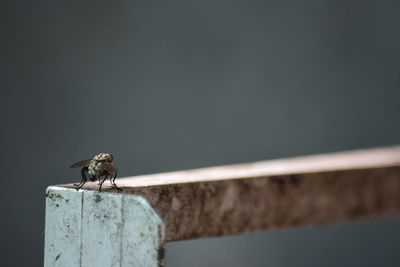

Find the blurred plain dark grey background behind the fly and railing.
[{"left": 0, "top": 0, "right": 400, "bottom": 267}]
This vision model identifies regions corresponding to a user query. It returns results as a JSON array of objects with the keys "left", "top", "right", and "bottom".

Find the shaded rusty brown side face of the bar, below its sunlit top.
[{"left": 122, "top": 166, "right": 400, "bottom": 241}]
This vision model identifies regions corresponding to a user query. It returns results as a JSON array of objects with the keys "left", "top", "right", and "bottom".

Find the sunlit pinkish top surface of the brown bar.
[{"left": 85, "top": 146, "right": 400, "bottom": 189}]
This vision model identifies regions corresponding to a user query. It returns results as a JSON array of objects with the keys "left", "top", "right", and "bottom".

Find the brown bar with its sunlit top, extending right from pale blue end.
[{"left": 61, "top": 146, "right": 400, "bottom": 241}]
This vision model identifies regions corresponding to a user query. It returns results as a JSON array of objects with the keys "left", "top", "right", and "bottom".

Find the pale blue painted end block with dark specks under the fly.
[{"left": 44, "top": 186, "right": 164, "bottom": 267}]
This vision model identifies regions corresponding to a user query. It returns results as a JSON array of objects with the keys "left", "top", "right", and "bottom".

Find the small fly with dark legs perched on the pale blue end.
[{"left": 71, "top": 153, "right": 121, "bottom": 191}]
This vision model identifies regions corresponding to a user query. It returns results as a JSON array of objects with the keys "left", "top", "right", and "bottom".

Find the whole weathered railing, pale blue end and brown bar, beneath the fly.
[{"left": 45, "top": 147, "right": 400, "bottom": 267}]
